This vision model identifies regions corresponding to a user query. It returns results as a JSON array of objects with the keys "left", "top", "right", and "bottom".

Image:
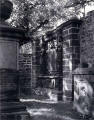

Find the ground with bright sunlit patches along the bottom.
[{"left": 20, "top": 99, "right": 94, "bottom": 120}]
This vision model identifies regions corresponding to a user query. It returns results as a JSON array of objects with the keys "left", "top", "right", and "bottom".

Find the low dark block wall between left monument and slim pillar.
[{"left": 19, "top": 54, "right": 33, "bottom": 97}]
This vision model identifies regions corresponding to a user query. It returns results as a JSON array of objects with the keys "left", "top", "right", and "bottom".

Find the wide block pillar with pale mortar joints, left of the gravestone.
[{"left": 63, "top": 19, "right": 81, "bottom": 101}]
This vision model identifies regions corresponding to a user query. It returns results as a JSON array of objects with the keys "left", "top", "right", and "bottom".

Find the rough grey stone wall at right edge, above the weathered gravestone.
[{"left": 80, "top": 11, "right": 94, "bottom": 64}]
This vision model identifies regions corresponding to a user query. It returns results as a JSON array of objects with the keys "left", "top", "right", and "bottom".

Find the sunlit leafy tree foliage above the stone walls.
[{"left": 10, "top": 0, "right": 74, "bottom": 32}]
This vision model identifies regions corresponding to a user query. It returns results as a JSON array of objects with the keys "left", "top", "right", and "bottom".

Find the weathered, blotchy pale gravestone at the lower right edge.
[{"left": 73, "top": 64, "right": 94, "bottom": 117}]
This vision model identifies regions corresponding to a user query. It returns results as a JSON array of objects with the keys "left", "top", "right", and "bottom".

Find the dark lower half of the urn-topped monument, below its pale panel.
[{"left": 0, "top": 69, "right": 30, "bottom": 120}]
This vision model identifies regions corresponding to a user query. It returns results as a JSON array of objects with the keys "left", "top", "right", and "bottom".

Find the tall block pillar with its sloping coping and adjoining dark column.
[{"left": 38, "top": 18, "right": 82, "bottom": 101}]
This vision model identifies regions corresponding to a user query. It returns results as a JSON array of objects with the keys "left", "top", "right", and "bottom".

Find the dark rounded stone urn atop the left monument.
[{"left": 0, "top": 0, "right": 13, "bottom": 20}]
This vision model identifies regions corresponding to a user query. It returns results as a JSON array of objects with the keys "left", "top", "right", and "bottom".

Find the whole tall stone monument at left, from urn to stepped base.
[{"left": 0, "top": 0, "right": 29, "bottom": 120}]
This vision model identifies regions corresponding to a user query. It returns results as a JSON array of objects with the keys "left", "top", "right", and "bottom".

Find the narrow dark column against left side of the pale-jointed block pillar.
[{"left": 56, "top": 29, "right": 63, "bottom": 101}]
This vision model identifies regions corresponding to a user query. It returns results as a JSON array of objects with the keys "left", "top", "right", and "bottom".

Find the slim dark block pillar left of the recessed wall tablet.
[{"left": 32, "top": 38, "right": 40, "bottom": 88}]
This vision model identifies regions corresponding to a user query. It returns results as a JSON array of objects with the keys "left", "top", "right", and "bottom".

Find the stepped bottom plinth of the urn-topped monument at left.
[{"left": 0, "top": 102, "right": 30, "bottom": 120}]
